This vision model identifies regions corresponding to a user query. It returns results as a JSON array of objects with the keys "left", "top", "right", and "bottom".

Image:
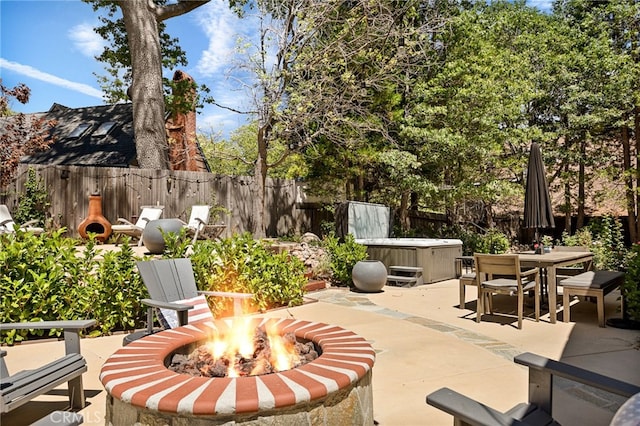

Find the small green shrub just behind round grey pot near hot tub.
[{"left": 322, "top": 232, "right": 367, "bottom": 287}]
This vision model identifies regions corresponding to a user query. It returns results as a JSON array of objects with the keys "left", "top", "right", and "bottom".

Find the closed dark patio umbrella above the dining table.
[{"left": 524, "top": 142, "right": 555, "bottom": 241}]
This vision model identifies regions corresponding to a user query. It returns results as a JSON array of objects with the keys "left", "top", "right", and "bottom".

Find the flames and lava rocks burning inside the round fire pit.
[{"left": 169, "top": 320, "right": 318, "bottom": 377}]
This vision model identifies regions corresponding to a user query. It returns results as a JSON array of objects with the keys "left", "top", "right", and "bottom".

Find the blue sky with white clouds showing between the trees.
[{"left": 0, "top": 0, "right": 551, "bottom": 137}]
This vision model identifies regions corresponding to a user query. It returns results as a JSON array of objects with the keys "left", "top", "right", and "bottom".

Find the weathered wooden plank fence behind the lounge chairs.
[{"left": 0, "top": 164, "right": 333, "bottom": 237}]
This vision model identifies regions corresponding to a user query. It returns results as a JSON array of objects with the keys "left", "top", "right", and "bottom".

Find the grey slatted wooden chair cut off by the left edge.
[{"left": 0, "top": 320, "right": 96, "bottom": 414}]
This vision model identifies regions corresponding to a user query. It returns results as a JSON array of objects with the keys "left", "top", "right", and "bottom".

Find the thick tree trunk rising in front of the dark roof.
[{"left": 118, "top": 0, "right": 169, "bottom": 169}]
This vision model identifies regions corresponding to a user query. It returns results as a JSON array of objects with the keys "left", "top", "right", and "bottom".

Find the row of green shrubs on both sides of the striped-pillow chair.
[{"left": 0, "top": 229, "right": 307, "bottom": 344}]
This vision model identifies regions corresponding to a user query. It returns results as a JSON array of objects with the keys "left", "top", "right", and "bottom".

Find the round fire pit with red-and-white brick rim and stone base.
[{"left": 100, "top": 318, "right": 375, "bottom": 426}]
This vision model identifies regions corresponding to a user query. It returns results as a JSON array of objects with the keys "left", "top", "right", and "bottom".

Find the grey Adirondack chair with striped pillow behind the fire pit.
[{"left": 124, "top": 258, "right": 253, "bottom": 345}]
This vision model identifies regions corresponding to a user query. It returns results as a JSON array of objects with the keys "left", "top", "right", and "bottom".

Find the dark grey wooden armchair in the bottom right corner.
[{"left": 427, "top": 352, "right": 640, "bottom": 426}]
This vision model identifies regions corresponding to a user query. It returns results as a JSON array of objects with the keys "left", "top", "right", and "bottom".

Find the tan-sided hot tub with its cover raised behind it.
[{"left": 356, "top": 238, "right": 462, "bottom": 284}]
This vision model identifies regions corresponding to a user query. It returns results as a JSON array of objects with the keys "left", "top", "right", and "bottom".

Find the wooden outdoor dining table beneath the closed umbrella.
[{"left": 518, "top": 250, "right": 593, "bottom": 324}]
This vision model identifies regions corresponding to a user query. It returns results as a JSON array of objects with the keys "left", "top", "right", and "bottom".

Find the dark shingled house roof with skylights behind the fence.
[{"left": 21, "top": 103, "right": 137, "bottom": 167}]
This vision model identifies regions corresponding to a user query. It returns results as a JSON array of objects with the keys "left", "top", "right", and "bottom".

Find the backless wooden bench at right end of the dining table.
[{"left": 559, "top": 271, "right": 624, "bottom": 327}]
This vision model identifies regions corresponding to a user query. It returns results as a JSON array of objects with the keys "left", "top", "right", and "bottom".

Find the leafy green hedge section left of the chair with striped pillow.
[{"left": 0, "top": 228, "right": 146, "bottom": 344}]
